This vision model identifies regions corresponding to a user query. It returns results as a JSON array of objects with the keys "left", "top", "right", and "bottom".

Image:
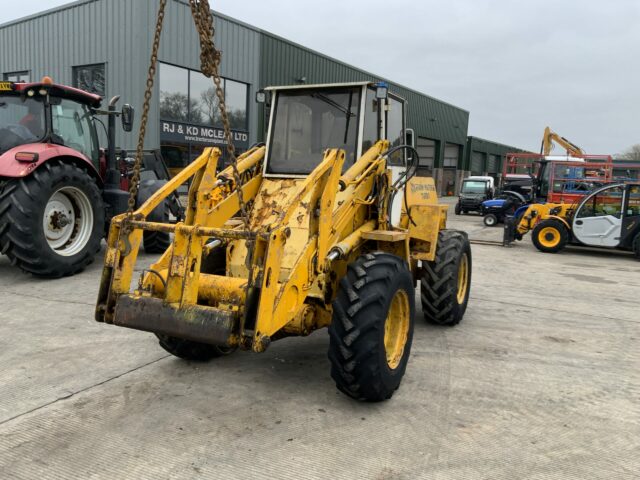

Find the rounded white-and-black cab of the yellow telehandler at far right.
[{"left": 571, "top": 184, "right": 640, "bottom": 248}]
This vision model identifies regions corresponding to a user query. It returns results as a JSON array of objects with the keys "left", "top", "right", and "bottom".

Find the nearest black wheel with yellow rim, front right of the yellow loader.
[{"left": 329, "top": 252, "right": 415, "bottom": 402}]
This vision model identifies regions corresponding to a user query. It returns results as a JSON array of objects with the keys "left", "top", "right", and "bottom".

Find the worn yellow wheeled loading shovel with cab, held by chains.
[{"left": 96, "top": 82, "right": 471, "bottom": 401}]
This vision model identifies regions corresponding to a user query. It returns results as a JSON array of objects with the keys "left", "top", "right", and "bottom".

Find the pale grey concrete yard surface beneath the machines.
[{"left": 0, "top": 200, "right": 640, "bottom": 480}]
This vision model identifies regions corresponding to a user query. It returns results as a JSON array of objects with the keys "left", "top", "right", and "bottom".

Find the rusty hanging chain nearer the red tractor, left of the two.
[{"left": 127, "top": 0, "right": 167, "bottom": 217}]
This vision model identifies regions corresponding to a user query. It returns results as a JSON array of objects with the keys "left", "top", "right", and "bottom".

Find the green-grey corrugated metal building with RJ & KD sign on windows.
[{"left": 0, "top": 0, "right": 515, "bottom": 194}]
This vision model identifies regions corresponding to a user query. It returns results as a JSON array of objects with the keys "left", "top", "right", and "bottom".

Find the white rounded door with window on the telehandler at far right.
[{"left": 572, "top": 185, "right": 624, "bottom": 247}]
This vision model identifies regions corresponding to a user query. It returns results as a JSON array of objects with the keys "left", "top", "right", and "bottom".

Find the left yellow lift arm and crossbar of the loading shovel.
[{"left": 96, "top": 147, "right": 264, "bottom": 323}]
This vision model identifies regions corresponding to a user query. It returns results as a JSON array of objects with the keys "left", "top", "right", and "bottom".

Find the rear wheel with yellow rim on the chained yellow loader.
[{"left": 420, "top": 230, "right": 471, "bottom": 326}]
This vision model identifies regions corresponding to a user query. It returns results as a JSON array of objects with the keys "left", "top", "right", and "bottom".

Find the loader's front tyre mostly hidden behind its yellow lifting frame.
[{"left": 156, "top": 247, "right": 236, "bottom": 362}]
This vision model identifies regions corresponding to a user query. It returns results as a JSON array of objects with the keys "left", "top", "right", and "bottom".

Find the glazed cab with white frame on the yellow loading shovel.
[{"left": 261, "top": 82, "right": 406, "bottom": 178}]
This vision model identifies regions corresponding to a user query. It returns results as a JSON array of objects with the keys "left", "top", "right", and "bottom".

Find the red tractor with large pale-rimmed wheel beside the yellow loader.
[{"left": 0, "top": 77, "right": 180, "bottom": 277}]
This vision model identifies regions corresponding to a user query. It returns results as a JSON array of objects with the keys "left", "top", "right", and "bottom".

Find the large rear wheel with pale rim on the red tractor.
[{"left": 0, "top": 160, "right": 105, "bottom": 278}]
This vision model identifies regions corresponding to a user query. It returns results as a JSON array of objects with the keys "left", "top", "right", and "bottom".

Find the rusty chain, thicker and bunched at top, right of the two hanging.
[{"left": 189, "top": 0, "right": 249, "bottom": 230}]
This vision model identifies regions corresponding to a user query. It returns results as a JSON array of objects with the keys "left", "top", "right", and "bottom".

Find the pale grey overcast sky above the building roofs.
[{"left": 0, "top": 0, "right": 640, "bottom": 154}]
